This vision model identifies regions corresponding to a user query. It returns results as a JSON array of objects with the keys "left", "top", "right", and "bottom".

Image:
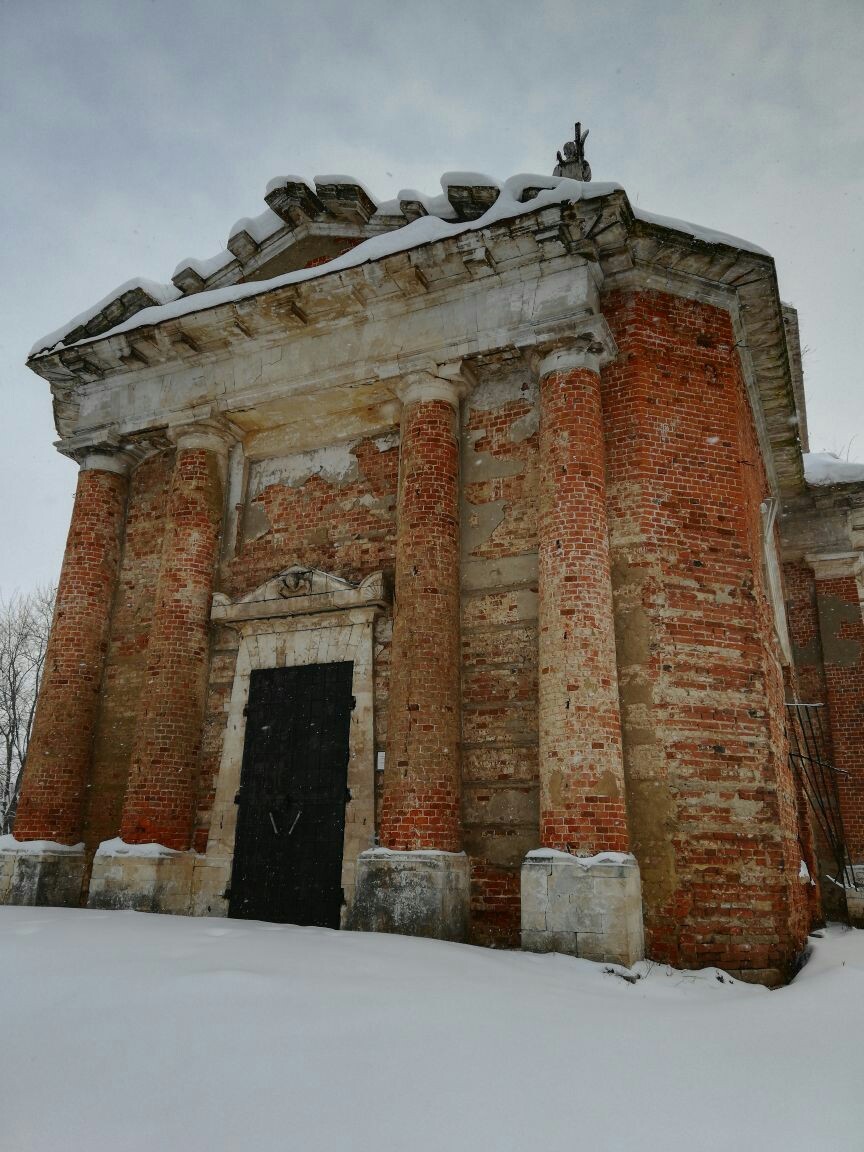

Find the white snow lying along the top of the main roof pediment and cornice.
[{"left": 29, "top": 172, "right": 768, "bottom": 358}]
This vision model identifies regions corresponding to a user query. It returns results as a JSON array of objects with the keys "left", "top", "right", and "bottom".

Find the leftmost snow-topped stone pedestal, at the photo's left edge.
[{"left": 0, "top": 836, "right": 84, "bottom": 908}]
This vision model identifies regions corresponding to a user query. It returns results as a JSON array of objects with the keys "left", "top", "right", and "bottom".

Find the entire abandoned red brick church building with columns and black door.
[{"left": 0, "top": 127, "right": 864, "bottom": 983}]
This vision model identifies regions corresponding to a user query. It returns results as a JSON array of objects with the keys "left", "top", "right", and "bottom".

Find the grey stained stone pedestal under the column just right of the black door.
[{"left": 347, "top": 848, "right": 470, "bottom": 941}]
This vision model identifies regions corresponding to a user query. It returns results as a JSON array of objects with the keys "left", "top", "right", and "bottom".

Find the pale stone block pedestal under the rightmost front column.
[{"left": 522, "top": 848, "right": 645, "bottom": 968}]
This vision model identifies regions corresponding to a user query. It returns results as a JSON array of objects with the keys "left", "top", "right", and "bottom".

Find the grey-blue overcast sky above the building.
[{"left": 0, "top": 0, "right": 864, "bottom": 594}]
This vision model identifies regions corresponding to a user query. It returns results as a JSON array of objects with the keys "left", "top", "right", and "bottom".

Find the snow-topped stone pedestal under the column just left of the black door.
[{"left": 88, "top": 840, "right": 198, "bottom": 916}]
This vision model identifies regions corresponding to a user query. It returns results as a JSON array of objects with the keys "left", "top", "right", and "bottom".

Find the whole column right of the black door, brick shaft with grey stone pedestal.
[{"left": 355, "top": 373, "right": 468, "bottom": 939}]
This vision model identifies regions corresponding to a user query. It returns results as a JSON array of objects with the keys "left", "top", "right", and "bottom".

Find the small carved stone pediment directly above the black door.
[{"left": 211, "top": 564, "right": 387, "bottom": 622}]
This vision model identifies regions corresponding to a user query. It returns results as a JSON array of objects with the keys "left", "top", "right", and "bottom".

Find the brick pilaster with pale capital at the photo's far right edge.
[{"left": 806, "top": 552, "right": 864, "bottom": 864}]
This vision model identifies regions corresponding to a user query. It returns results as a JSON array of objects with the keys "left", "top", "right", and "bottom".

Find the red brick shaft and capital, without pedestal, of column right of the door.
[{"left": 379, "top": 374, "right": 462, "bottom": 851}]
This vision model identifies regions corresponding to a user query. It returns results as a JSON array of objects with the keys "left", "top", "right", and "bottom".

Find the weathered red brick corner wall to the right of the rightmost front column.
[{"left": 604, "top": 293, "right": 806, "bottom": 973}]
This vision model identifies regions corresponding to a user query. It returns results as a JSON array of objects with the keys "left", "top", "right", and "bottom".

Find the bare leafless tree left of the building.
[{"left": 0, "top": 585, "right": 56, "bottom": 833}]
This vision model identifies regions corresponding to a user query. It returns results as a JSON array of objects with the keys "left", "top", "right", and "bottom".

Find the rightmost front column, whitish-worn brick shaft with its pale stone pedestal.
[{"left": 522, "top": 331, "right": 643, "bottom": 963}]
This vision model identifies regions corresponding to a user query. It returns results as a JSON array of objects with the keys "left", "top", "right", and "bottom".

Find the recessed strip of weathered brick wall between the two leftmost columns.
[{"left": 83, "top": 453, "right": 174, "bottom": 852}]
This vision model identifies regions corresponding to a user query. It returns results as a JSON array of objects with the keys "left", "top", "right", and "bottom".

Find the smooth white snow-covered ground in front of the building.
[{"left": 0, "top": 908, "right": 864, "bottom": 1152}]
